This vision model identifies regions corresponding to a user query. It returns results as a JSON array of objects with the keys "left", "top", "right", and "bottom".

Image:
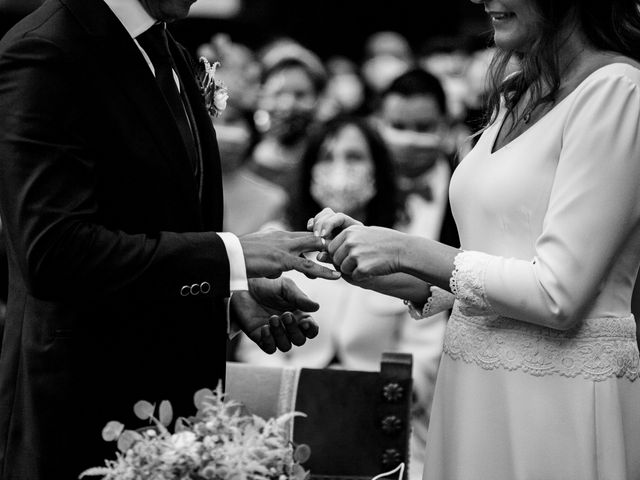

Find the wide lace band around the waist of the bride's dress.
[{"left": 444, "top": 302, "right": 640, "bottom": 381}]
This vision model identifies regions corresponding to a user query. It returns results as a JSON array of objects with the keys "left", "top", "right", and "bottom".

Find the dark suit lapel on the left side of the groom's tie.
[{"left": 60, "top": 0, "right": 199, "bottom": 218}]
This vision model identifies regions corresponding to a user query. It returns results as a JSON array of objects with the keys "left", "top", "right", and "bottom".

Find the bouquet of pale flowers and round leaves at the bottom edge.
[{"left": 80, "top": 384, "right": 310, "bottom": 480}]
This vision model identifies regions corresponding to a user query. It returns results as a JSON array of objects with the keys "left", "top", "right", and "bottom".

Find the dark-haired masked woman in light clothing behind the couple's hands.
[{"left": 236, "top": 117, "right": 446, "bottom": 479}]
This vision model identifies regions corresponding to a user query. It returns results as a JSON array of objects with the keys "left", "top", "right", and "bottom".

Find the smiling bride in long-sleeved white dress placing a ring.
[{"left": 309, "top": 0, "right": 640, "bottom": 480}]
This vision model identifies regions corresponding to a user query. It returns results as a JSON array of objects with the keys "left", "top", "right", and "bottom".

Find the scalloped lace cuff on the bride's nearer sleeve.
[{"left": 449, "top": 251, "right": 494, "bottom": 315}]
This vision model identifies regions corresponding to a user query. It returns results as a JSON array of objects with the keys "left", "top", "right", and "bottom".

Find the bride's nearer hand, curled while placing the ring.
[{"left": 325, "top": 226, "right": 406, "bottom": 282}]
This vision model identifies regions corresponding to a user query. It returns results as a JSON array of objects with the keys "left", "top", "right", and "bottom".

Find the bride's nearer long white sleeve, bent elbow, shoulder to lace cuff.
[{"left": 451, "top": 68, "right": 640, "bottom": 329}]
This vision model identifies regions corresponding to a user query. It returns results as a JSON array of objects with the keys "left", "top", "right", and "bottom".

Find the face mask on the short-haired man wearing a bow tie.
[{"left": 381, "top": 126, "right": 448, "bottom": 178}]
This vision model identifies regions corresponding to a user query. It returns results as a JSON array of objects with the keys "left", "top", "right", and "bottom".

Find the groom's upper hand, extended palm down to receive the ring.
[{"left": 240, "top": 230, "right": 340, "bottom": 280}]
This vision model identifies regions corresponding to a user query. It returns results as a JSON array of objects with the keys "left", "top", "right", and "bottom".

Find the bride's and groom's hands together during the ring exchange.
[{"left": 231, "top": 208, "right": 402, "bottom": 353}]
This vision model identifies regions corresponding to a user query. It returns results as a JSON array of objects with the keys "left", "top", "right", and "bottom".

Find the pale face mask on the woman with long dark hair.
[{"left": 311, "top": 162, "right": 376, "bottom": 213}]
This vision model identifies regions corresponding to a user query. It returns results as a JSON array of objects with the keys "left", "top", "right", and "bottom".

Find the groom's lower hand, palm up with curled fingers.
[{"left": 231, "top": 278, "right": 318, "bottom": 353}]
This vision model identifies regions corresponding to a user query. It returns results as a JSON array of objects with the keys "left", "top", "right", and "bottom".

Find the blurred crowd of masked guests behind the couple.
[{"left": 0, "top": 0, "right": 636, "bottom": 478}]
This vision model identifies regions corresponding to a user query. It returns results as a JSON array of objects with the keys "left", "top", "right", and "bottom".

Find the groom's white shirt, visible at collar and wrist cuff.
[{"left": 104, "top": 0, "right": 249, "bottom": 292}]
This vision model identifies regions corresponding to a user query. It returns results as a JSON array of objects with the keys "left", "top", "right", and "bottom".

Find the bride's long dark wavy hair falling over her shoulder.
[{"left": 486, "top": 0, "right": 640, "bottom": 123}]
